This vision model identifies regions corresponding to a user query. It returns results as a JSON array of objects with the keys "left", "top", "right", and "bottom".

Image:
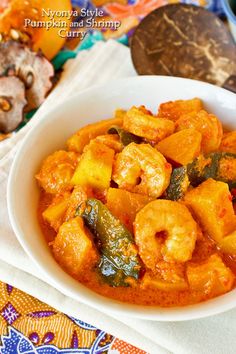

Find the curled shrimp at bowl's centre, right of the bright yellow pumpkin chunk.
[{"left": 112, "top": 143, "right": 171, "bottom": 198}]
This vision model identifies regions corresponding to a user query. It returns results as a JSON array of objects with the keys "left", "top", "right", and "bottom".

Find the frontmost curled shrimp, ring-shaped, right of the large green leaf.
[{"left": 134, "top": 199, "right": 198, "bottom": 271}]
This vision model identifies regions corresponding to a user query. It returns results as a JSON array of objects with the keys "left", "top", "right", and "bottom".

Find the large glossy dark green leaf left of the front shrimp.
[{"left": 78, "top": 199, "right": 141, "bottom": 286}]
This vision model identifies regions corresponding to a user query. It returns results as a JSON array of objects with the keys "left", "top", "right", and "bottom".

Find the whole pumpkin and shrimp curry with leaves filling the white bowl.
[{"left": 36, "top": 98, "right": 236, "bottom": 307}]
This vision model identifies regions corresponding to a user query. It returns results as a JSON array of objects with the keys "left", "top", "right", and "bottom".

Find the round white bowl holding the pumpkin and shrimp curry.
[{"left": 8, "top": 76, "right": 236, "bottom": 321}]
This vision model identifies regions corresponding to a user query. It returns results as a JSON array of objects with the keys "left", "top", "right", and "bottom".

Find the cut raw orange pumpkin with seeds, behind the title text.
[{"left": 0, "top": 0, "right": 71, "bottom": 59}]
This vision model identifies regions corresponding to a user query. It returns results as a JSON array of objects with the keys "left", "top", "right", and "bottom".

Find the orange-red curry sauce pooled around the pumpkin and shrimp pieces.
[{"left": 38, "top": 191, "right": 236, "bottom": 307}]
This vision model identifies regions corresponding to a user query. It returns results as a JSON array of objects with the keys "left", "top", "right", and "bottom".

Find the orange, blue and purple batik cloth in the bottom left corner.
[{"left": 0, "top": 282, "right": 145, "bottom": 354}]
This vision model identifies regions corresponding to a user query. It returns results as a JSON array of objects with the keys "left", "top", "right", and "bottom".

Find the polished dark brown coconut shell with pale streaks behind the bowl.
[{"left": 131, "top": 4, "right": 236, "bottom": 85}]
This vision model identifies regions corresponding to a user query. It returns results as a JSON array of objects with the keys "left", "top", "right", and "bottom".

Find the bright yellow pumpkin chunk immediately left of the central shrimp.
[{"left": 71, "top": 141, "right": 115, "bottom": 190}]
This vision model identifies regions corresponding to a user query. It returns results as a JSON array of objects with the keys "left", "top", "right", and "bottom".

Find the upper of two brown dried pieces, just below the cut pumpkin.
[{"left": 0, "top": 41, "right": 54, "bottom": 111}]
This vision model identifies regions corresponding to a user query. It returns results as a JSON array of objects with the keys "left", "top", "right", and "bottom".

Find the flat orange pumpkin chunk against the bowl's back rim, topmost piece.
[{"left": 157, "top": 98, "right": 203, "bottom": 121}]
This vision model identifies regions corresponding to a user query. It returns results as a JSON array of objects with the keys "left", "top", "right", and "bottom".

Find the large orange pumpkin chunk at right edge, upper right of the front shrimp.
[{"left": 184, "top": 178, "right": 236, "bottom": 242}]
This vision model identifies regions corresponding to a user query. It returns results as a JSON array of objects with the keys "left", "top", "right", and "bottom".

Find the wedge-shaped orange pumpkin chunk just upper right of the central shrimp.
[{"left": 156, "top": 129, "right": 202, "bottom": 165}]
